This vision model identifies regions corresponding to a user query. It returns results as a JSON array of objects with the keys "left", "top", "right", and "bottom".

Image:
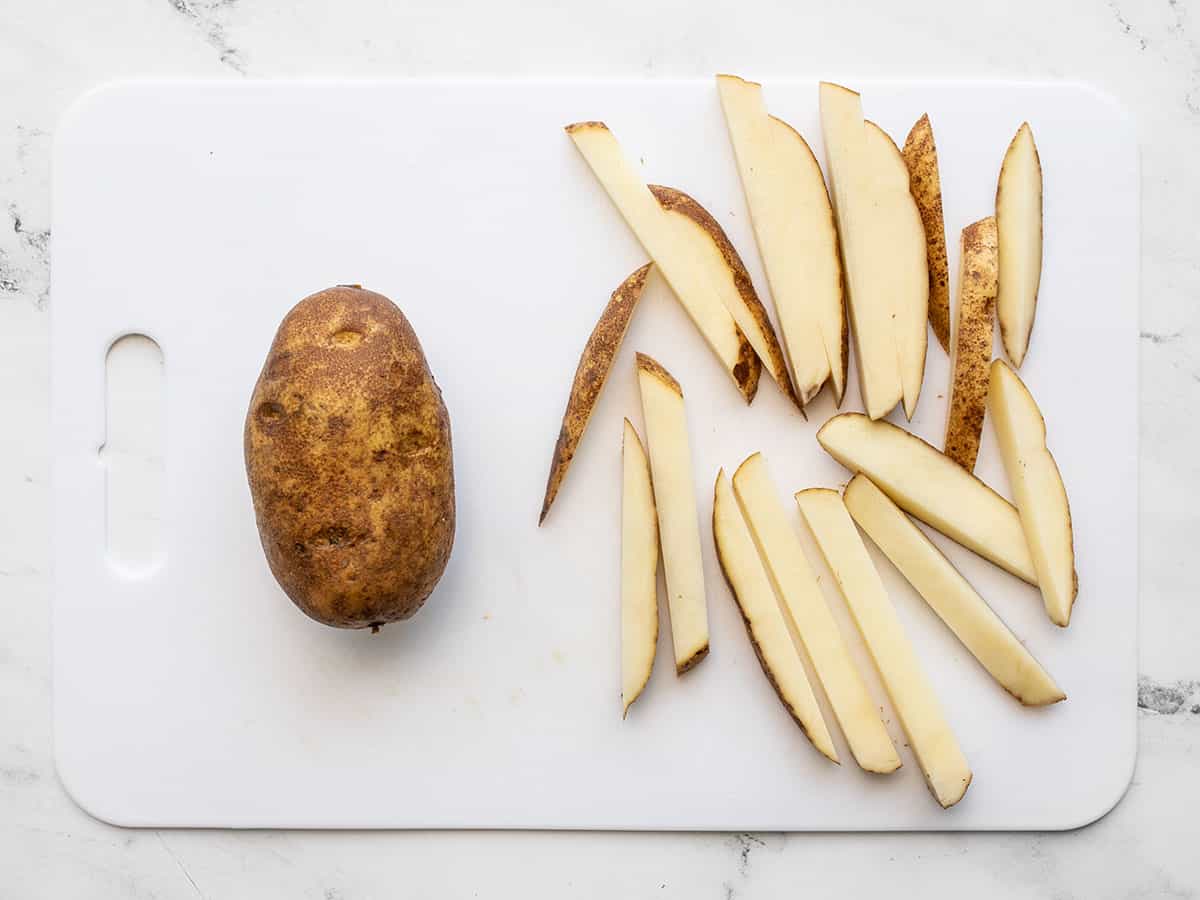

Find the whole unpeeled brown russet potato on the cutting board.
[{"left": 245, "top": 286, "right": 455, "bottom": 629}]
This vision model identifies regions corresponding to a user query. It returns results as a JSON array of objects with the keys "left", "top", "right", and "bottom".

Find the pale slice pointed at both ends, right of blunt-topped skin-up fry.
[{"left": 996, "top": 122, "right": 1042, "bottom": 368}]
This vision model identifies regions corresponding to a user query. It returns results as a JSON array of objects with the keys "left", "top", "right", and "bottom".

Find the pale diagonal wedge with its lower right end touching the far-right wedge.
[{"left": 817, "top": 413, "right": 1038, "bottom": 584}]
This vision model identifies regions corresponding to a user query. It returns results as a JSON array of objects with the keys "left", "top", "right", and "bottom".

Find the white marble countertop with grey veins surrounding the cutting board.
[{"left": 0, "top": 0, "right": 1200, "bottom": 900}]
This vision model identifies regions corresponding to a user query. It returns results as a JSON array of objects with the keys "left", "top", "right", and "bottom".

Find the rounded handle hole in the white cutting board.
[{"left": 97, "top": 334, "right": 167, "bottom": 578}]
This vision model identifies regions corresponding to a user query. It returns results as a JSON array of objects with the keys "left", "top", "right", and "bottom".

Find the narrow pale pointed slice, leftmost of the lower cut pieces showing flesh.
[{"left": 620, "top": 419, "right": 659, "bottom": 718}]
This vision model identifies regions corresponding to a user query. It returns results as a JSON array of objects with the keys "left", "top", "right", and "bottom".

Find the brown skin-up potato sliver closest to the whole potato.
[{"left": 538, "top": 263, "right": 653, "bottom": 526}]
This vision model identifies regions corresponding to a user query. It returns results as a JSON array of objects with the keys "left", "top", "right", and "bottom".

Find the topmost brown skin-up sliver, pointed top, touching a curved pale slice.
[{"left": 901, "top": 113, "right": 950, "bottom": 353}]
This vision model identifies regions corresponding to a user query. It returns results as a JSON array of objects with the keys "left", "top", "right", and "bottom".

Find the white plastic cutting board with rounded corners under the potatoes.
[{"left": 52, "top": 79, "right": 1139, "bottom": 830}]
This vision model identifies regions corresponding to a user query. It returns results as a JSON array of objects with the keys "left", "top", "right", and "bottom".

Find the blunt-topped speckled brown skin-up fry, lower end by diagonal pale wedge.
[{"left": 946, "top": 216, "right": 996, "bottom": 472}]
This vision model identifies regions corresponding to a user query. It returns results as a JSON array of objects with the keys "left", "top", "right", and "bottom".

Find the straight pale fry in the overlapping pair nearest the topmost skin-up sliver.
[{"left": 820, "top": 82, "right": 904, "bottom": 419}]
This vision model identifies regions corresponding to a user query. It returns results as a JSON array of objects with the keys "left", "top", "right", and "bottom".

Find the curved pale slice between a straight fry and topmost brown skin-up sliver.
[{"left": 865, "top": 121, "right": 929, "bottom": 419}]
